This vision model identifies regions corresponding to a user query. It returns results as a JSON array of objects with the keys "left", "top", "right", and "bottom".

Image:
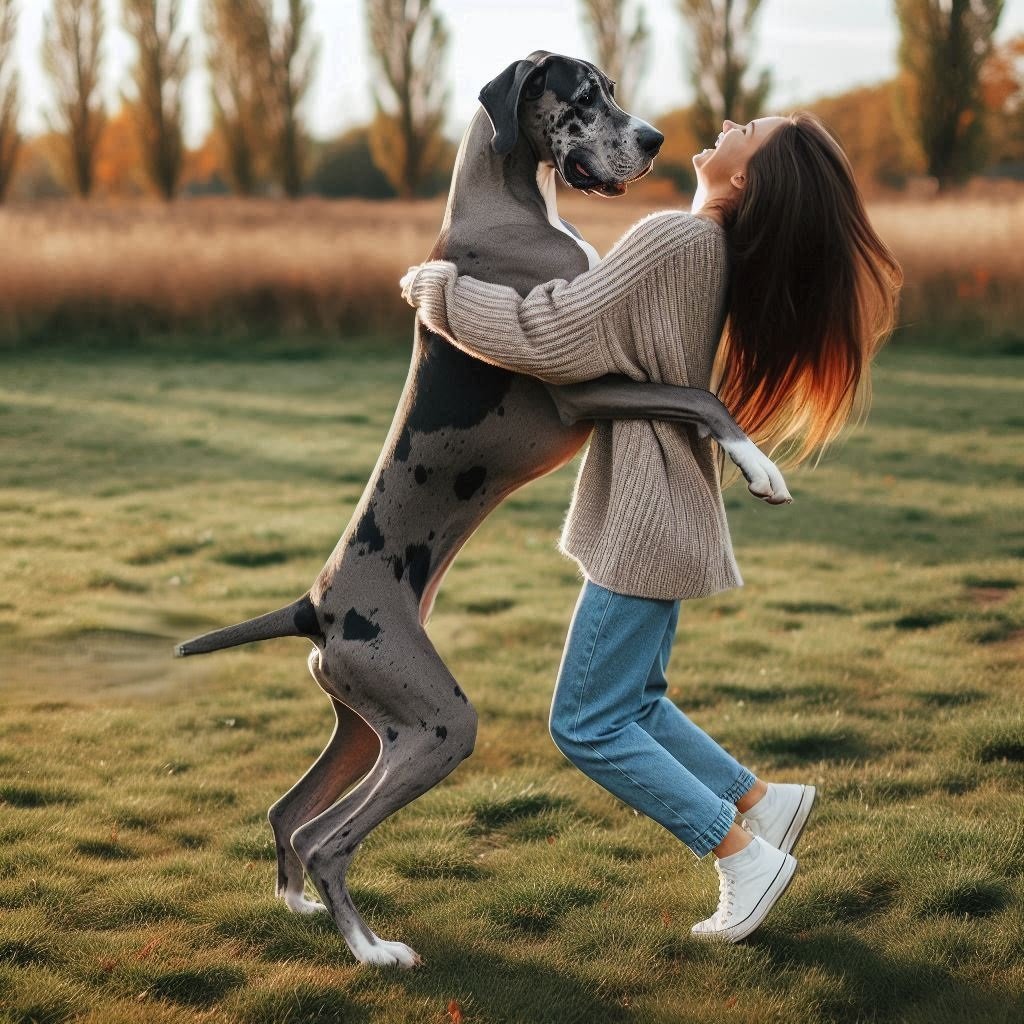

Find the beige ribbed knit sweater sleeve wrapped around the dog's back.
[{"left": 408, "top": 211, "right": 721, "bottom": 384}]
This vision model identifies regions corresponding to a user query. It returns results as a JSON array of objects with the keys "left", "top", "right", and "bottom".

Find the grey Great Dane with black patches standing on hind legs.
[{"left": 176, "top": 51, "right": 788, "bottom": 967}]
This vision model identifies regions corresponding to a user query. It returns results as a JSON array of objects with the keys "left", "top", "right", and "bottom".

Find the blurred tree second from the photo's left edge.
[{"left": 43, "top": 0, "right": 105, "bottom": 198}]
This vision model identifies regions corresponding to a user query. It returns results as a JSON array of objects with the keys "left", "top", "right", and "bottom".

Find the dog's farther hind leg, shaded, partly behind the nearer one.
[{"left": 267, "top": 648, "right": 381, "bottom": 913}]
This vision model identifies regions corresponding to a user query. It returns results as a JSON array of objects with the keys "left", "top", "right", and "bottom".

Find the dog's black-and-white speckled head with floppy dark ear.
[{"left": 480, "top": 50, "right": 665, "bottom": 196}]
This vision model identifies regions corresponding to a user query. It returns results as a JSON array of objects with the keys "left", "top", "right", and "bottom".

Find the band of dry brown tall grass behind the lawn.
[{"left": 0, "top": 191, "right": 1024, "bottom": 343}]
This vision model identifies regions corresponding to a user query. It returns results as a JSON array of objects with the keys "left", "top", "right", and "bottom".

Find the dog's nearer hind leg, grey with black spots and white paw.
[{"left": 292, "top": 626, "right": 477, "bottom": 968}]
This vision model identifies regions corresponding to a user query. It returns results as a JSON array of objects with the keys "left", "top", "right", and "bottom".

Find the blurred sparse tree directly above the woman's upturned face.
[{"left": 678, "top": 0, "right": 771, "bottom": 146}]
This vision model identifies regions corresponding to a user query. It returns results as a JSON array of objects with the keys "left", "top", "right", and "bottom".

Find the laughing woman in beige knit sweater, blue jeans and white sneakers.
[{"left": 402, "top": 113, "right": 902, "bottom": 942}]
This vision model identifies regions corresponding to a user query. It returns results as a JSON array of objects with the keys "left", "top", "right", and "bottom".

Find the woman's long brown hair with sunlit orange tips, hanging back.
[{"left": 711, "top": 112, "right": 903, "bottom": 481}]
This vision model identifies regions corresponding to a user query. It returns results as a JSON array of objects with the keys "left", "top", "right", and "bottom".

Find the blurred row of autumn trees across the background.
[{"left": 0, "top": 0, "right": 1024, "bottom": 200}]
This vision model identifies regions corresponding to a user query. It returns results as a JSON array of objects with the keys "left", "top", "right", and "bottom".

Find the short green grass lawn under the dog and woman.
[{"left": 0, "top": 331, "right": 1024, "bottom": 1024}]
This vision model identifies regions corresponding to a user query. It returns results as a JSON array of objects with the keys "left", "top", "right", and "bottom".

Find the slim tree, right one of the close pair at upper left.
[{"left": 267, "top": 0, "right": 319, "bottom": 198}]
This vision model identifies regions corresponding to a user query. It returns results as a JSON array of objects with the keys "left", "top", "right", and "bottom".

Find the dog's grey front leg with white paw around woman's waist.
[{"left": 547, "top": 374, "right": 793, "bottom": 505}]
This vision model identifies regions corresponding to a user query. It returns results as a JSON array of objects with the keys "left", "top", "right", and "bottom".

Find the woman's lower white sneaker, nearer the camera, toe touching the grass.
[{"left": 690, "top": 829, "right": 797, "bottom": 942}]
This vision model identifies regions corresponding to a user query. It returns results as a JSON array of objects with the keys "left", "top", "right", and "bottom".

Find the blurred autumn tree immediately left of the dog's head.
[{"left": 367, "top": 0, "right": 449, "bottom": 198}]
